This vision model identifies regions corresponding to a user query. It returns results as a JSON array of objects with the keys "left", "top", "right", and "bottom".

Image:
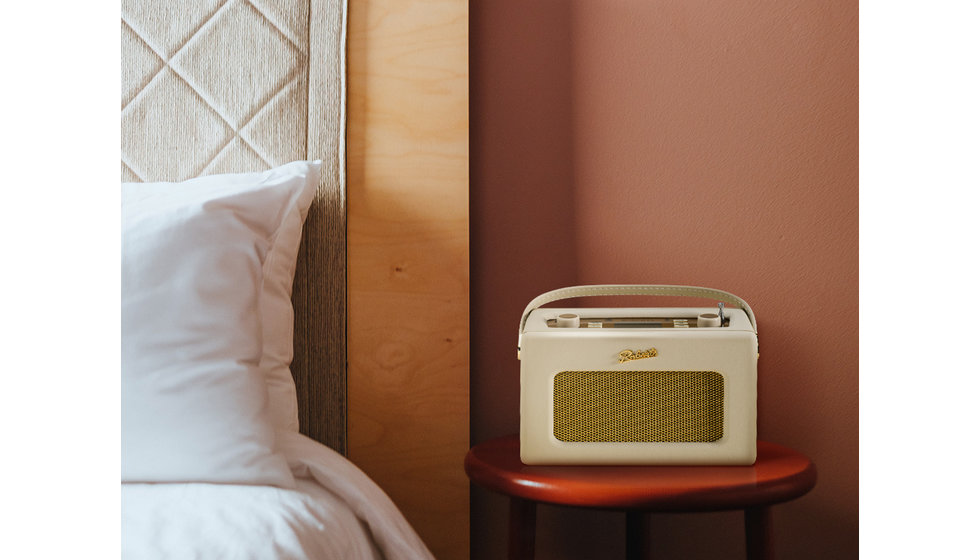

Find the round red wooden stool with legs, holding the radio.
[{"left": 464, "top": 435, "right": 817, "bottom": 560}]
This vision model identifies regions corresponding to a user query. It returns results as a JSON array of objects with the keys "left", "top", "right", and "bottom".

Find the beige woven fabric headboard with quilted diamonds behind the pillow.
[{"left": 121, "top": 0, "right": 347, "bottom": 452}]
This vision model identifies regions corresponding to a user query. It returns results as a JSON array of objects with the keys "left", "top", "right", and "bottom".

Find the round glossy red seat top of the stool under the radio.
[{"left": 464, "top": 435, "right": 817, "bottom": 511}]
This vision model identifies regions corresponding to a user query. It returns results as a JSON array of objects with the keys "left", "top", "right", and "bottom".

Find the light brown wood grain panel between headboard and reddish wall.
[{"left": 347, "top": 0, "right": 469, "bottom": 560}]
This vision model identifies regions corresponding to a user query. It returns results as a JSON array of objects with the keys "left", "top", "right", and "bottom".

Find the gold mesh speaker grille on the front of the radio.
[{"left": 555, "top": 371, "right": 725, "bottom": 443}]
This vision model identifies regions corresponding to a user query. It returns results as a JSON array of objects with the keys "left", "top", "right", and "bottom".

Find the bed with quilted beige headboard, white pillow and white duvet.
[{"left": 121, "top": 0, "right": 448, "bottom": 558}]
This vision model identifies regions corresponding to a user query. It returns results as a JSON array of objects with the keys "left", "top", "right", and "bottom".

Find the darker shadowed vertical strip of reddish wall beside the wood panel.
[{"left": 461, "top": 0, "right": 577, "bottom": 559}]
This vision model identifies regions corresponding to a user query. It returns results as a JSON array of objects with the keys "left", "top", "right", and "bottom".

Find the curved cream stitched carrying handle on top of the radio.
[{"left": 517, "top": 284, "right": 759, "bottom": 357}]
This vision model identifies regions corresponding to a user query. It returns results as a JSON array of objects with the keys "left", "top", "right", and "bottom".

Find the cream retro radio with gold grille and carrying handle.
[{"left": 518, "top": 285, "right": 759, "bottom": 465}]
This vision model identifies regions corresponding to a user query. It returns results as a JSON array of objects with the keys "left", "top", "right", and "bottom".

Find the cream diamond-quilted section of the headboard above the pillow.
[{"left": 121, "top": 0, "right": 309, "bottom": 181}]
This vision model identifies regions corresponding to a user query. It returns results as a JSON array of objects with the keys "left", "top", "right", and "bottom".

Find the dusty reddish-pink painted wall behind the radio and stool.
[{"left": 470, "top": 0, "right": 858, "bottom": 559}]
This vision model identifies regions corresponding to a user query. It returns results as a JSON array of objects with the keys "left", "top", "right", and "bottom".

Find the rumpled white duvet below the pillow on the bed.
[{"left": 122, "top": 432, "right": 432, "bottom": 560}]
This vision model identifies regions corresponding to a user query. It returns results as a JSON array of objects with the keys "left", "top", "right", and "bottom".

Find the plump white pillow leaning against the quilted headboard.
[{"left": 121, "top": 162, "right": 320, "bottom": 487}]
